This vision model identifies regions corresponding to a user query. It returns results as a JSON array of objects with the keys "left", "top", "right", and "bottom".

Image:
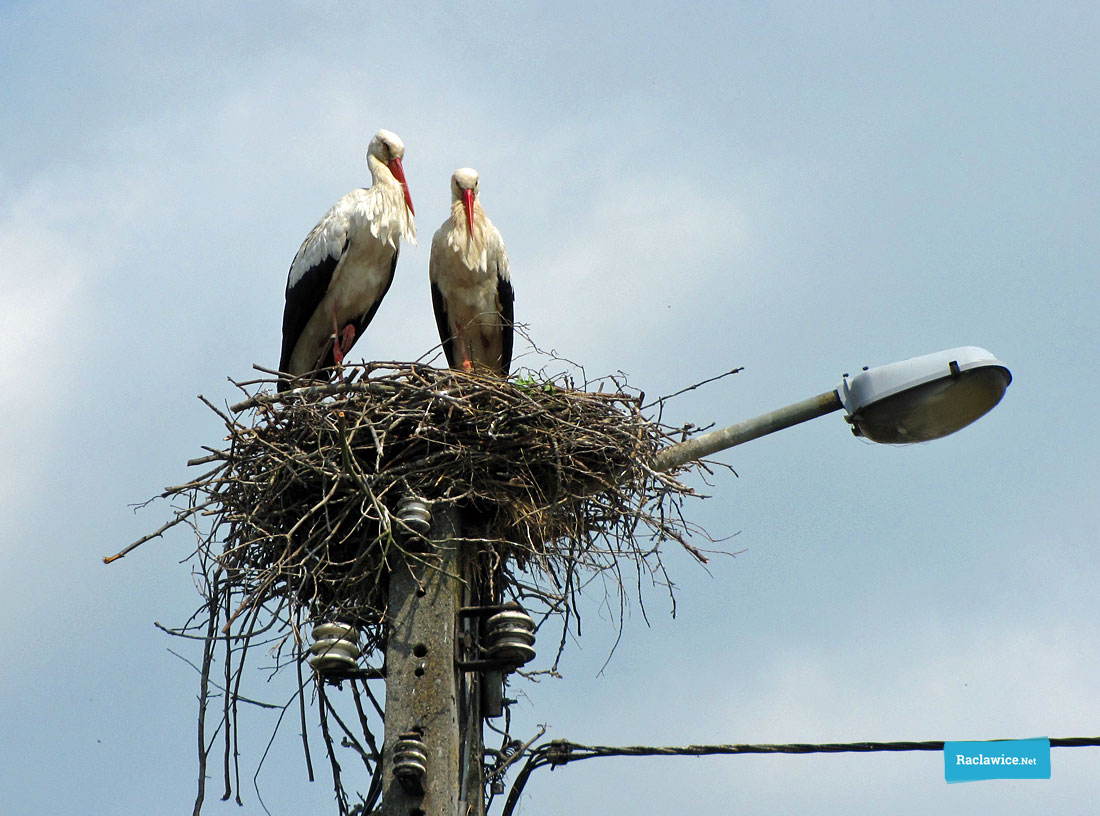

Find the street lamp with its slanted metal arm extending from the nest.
[{"left": 653, "top": 345, "right": 1012, "bottom": 471}]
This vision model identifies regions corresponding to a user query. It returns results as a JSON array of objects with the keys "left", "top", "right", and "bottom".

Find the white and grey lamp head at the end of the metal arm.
[{"left": 836, "top": 345, "right": 1012, "bottom": 444}]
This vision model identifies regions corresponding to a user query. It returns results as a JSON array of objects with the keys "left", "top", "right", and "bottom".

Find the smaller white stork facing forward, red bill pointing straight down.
[{"left": 428, "top": 167, "right": 514, "bottom": 376}]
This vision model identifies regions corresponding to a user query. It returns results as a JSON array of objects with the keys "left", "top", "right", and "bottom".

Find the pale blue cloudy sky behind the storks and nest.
[{"left": 0, "top": 0, "right": 1100, "bottom": 816}]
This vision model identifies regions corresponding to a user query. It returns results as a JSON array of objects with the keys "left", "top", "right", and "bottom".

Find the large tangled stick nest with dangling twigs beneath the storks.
[{"left": 118, "top": 363, "right": 730, "bottom": 812}]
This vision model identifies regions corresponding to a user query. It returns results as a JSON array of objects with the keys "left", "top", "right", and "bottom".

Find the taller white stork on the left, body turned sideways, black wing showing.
[{"left": 278, "top": 130, "right": 416, "bottom": 392}]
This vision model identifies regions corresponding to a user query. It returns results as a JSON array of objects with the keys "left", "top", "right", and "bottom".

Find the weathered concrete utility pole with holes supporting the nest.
[{"left": 382, "top": 509, "right": 484, "bottom": 816}]
